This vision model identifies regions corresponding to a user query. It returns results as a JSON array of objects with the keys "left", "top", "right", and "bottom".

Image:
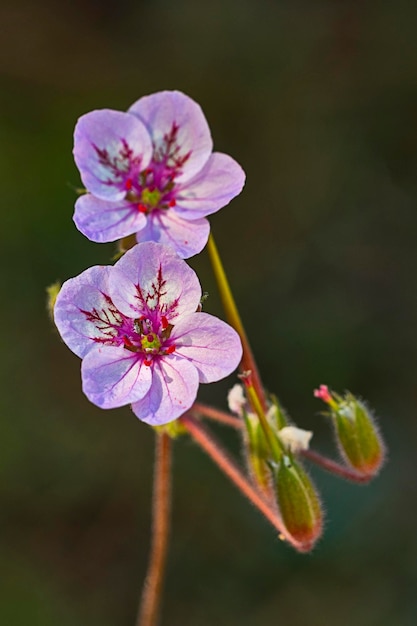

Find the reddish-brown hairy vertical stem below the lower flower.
[{"left": 136, "top": 432, "right": 171, "bottom": 626}]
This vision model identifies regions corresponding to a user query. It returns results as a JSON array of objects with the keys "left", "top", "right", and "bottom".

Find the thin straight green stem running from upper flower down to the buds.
[{"left": 207, "top": 234, "right": 267, "bottom": 410}]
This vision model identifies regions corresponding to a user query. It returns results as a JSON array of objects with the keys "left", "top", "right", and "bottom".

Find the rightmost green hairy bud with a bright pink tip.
[{"left": 315, "top": 385, "right": 385, "bottom": 478}]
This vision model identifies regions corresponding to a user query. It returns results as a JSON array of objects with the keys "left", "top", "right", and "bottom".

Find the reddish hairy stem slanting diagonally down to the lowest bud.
[{"left": 180, "top": 414, "right": 312, "bottom": 552}]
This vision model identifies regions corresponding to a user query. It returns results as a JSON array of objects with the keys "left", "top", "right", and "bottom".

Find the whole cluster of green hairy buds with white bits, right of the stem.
[{"left": 228, "top": 377, "right": 385, "bottom": 552}]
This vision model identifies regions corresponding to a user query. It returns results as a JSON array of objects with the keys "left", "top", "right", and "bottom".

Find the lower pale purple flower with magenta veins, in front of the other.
[{"left": 55, "top": 242, "right": 242, "bottom": 425}]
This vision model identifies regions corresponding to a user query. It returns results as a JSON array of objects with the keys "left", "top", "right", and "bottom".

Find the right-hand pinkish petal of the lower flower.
[{"left": 171, "top": 313, "right": 242, "bottom": 383}]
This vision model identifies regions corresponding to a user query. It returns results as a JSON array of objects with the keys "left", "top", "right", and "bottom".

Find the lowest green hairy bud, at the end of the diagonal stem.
[{"left": 276, "top": 455, "right": 323, "bottom": 550}]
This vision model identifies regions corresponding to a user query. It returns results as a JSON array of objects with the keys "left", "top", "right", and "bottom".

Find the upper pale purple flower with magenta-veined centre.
[{"left": 74, "top": 91, "right": 245, "bottom": 258}]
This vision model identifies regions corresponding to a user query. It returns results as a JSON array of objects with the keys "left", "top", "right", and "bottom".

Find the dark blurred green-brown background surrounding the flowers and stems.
[{"left": 0, "top": 0, "right": 417, "bottom": 626}]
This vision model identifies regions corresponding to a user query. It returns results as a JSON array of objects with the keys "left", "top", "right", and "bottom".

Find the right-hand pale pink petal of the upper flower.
[{"left": 175, "top": 152, "right": 245, "bottom": 220}]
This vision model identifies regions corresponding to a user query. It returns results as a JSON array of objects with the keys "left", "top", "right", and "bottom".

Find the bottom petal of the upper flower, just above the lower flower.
[{"left": 136, "top": 208, "right": 210, "bottom": 259}]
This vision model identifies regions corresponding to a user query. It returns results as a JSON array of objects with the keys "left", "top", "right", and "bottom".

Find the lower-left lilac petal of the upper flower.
[{"left": 74, "top": 193, "right": 146, "bottom": 243}]
